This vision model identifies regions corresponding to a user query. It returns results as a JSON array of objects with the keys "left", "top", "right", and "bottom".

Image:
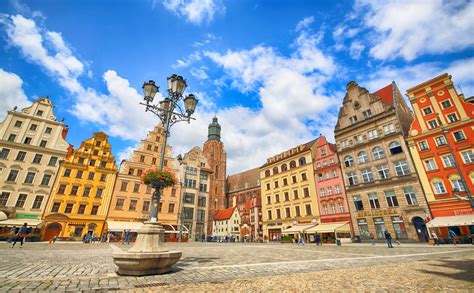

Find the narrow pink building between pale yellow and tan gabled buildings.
[{"left": 314, "top": 135, "right": 351, "bottom": 223}]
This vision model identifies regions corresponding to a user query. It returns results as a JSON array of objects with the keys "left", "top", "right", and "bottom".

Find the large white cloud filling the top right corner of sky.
[{"left": 356, "top": 0, "right": 474, "bottom": 61}]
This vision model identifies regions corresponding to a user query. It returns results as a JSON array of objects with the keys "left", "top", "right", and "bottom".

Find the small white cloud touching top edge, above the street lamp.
[{"left": 162, "top": 0, "right": 225, "bottom": 25}]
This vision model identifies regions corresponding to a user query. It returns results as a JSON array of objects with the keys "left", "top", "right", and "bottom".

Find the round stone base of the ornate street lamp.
[{"left": 113, "top": 222, "right": 182, "bottom": 276}]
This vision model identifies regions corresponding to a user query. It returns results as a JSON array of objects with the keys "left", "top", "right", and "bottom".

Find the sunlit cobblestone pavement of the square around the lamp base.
[{"left": 0, "top": 243, "right": 474, "bottom": 292}]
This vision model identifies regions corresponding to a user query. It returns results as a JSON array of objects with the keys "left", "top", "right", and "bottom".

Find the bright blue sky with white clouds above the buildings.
[{"left": 0, "top": 0, "right": 474, "bottom": 174}]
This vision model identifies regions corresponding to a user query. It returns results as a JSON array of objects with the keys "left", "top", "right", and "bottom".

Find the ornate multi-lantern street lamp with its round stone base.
[{"left": 114, "top": 74, "right": 198, "bottom": 276}]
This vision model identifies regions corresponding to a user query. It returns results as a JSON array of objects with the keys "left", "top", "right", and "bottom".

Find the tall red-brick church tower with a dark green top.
[{"left": 203, "top": 117, "right": 227, "bottom": 235}]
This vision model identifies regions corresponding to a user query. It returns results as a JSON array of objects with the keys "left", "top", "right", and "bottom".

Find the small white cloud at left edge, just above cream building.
[{"left": 0, "top": 68, "right": 30, "bottom": 121}]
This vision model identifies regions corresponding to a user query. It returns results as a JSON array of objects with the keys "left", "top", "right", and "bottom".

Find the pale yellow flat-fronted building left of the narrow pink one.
[{"left": 260, "top": 140, "right": 320, "bottom": 241}]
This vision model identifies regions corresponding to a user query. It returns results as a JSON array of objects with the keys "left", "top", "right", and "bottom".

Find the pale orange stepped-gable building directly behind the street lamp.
[{"left": 107, "top": 126, "right": 180, "bottom": 238}]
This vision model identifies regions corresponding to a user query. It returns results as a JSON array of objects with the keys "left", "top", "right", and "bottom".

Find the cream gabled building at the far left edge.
[{"left": 0, "top": 97, "right": 71, "bottom": 227}]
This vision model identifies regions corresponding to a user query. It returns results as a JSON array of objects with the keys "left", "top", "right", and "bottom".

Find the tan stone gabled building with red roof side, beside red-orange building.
[{"left": 335, "top": 82, "right": 430, "bottom": 241}]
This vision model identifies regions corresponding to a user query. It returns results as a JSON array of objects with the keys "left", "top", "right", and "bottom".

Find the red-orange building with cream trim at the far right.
[{"left": 407, "top": 73, "right": 474, "bottom": 240}]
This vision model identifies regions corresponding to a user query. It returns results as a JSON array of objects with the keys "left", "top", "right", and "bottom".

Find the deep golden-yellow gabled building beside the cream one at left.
[{"left": 42, "top": 132, "right": 117, "bottom": 240}]
